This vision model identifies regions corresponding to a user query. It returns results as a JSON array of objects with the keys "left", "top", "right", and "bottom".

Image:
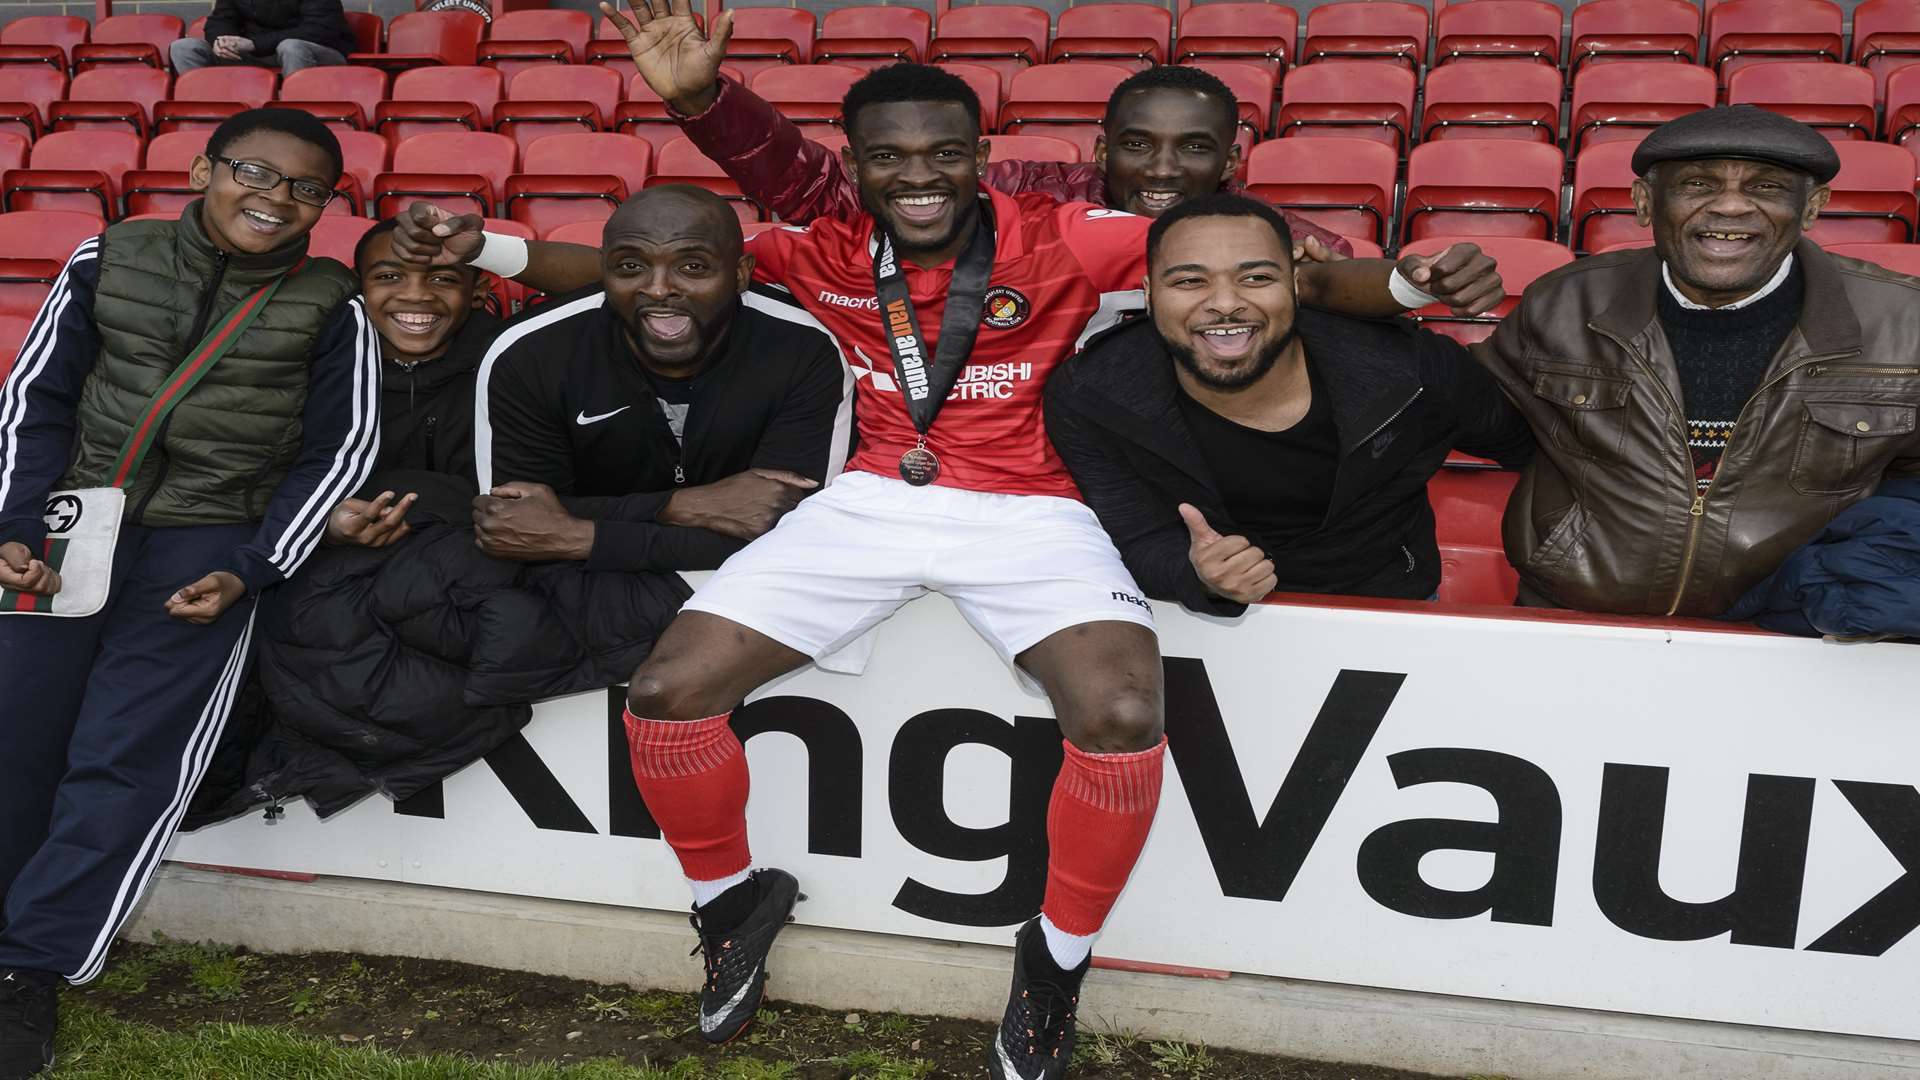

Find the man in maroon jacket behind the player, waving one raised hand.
[{"left": 601, "top": 0, "right": 1501, "bottom": 313}]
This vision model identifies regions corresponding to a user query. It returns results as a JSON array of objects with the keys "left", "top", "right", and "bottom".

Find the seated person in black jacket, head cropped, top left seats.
[{"left": 173, "top": 0, "right": 353, "bottom": 75}]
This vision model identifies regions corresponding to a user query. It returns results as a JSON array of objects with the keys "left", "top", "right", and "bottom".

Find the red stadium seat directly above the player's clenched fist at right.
[{"left": 1400, "top": 138, "right": 1565, "bottom": 240}]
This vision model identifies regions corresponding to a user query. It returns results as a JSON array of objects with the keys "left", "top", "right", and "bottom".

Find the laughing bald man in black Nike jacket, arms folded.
[{"left": 455, "top": 184, "right": 852, "bottom": 571}]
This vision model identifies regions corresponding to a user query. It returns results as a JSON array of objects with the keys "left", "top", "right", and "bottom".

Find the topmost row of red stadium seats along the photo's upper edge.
[{"left": 18, "top": 0, "right": 1920, "bottom": 96}]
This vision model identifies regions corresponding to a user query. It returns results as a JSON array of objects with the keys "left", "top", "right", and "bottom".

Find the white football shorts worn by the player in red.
[{"left": 682, "top": 471, "right": 1154, "bottom": 675}]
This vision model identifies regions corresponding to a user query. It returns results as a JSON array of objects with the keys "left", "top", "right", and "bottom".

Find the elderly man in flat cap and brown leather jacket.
[{"left": 1476, "top": 106, "right": 1920, "bottom": 615}]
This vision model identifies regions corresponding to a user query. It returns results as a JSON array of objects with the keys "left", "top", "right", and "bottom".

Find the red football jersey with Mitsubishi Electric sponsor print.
[{"left": 747, "top": 192, "right": 1150, "bottom": 500}]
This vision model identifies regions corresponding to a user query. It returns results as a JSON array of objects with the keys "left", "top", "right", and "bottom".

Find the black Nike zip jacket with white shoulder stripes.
[{"left": 474, "top": 286, "right": 852, "bottom": 571}]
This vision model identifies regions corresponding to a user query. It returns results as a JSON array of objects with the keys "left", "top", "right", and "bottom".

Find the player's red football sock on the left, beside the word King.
[{"left": 626, "top": 711, "right": 753, "bottom": 882}]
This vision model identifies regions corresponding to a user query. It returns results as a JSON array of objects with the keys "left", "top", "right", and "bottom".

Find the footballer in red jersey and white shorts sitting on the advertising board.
[{"left": 626, "top": 63, "right": 1165, "bottom": 1080}]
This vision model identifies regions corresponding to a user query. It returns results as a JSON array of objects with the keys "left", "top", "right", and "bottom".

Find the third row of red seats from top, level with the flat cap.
[{"left": 0, "top": 117, "right": 1920, "bottom": 254}]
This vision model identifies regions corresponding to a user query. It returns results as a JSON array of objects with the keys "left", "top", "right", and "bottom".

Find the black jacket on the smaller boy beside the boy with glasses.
[{"left": 374, "top": 311, "right": 505, "bottom": 486}]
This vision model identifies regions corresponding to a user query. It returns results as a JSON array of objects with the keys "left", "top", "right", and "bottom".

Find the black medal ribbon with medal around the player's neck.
[{"left": 874, "top": 200, "right": 995, "bottom": 486}]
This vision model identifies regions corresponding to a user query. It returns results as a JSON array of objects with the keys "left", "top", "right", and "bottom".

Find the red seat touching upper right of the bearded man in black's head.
[{"left": 1246, "top": 138, "right": 1400, "bottom": 244}]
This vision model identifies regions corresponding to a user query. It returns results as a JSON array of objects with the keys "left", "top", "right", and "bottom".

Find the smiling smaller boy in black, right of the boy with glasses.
[{"left": 326, "top": 217, "right": 501, "bottom": 548}]
